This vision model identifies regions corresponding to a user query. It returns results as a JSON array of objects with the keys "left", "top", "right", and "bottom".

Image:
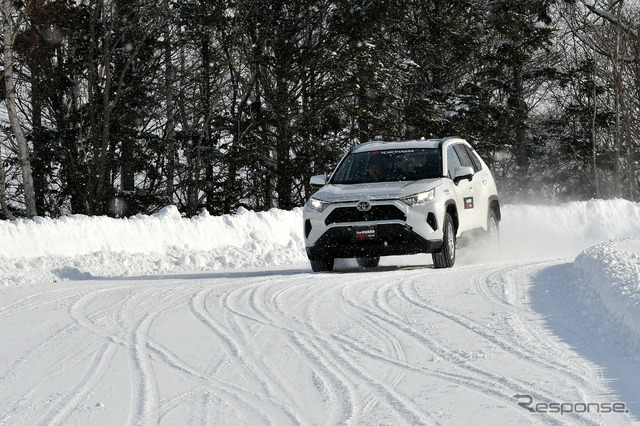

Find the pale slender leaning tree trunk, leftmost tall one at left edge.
[{"left": 2, "top": 0, "right": 37, "bottom": 218}]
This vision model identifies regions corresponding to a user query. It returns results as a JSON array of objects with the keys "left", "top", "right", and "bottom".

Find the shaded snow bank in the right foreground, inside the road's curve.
[{"left": 573, "top": 239, "right": 640, "bottom": 356}]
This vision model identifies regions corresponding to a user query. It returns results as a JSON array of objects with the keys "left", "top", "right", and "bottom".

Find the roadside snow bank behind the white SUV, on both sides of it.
[{"left": 0, "top": 200, "right": 640, "bottom": 285}]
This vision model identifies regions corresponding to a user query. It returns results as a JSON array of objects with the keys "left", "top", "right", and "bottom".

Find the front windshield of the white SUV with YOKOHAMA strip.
[{"left": 330, "top": 148, "right": 442, "bottom": 185}]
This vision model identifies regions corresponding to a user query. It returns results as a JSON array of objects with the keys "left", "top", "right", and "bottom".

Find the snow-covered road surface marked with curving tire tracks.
[{"left": 0, "top": 260, "right": 640, "bottom": 425}]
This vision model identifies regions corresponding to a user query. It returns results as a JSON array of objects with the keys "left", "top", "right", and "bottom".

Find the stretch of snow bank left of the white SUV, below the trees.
[{"left": 0, "top": 206, "right": 306, "bottom": 285}]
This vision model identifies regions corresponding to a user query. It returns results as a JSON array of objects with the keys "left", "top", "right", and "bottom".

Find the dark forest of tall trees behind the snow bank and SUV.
[{"left": 0, "top": 0, "right": 640, "bottom": 219}]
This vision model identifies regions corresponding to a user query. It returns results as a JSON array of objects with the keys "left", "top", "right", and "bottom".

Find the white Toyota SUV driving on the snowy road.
[{"left": 303, "top": 137, "right": 500, "bottom": 272}]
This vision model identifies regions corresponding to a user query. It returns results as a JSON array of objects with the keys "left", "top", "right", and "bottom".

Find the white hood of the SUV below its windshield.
[{"left": 313, "top": 179, "right": 442, "bottom": 202}]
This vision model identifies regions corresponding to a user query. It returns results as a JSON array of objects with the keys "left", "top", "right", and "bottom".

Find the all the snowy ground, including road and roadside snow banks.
[{"left": 0, "top": 200, "right": 640, "bottom": 425}]
